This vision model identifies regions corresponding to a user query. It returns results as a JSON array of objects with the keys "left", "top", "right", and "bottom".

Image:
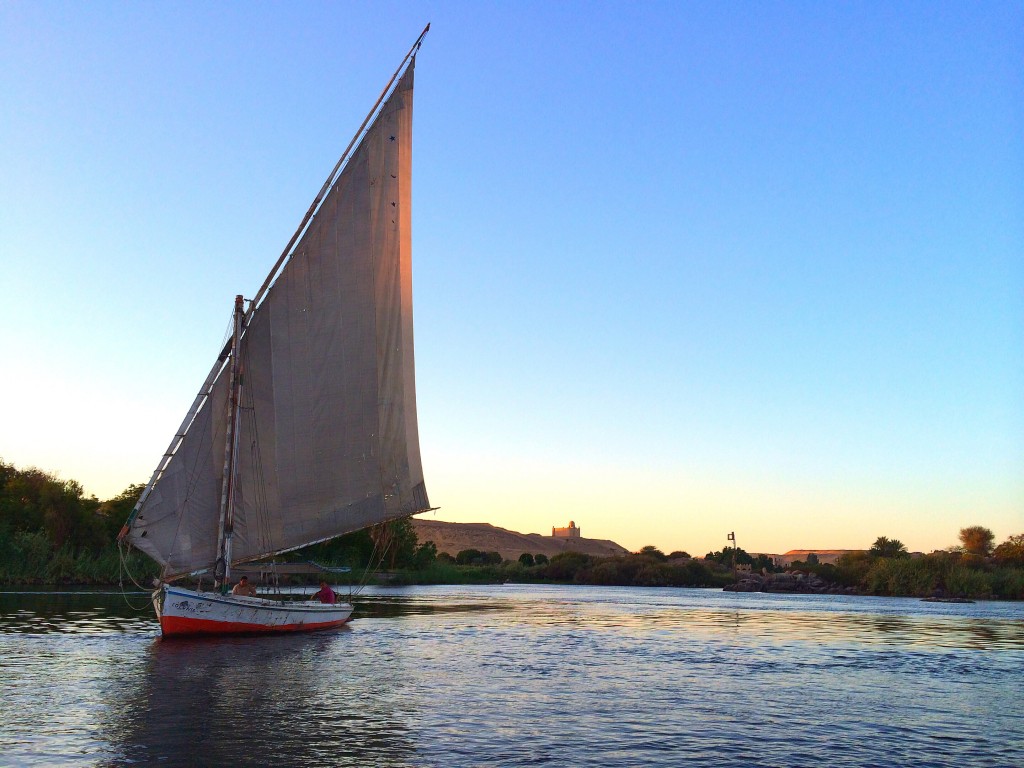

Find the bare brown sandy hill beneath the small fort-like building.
[{"left": 413, "top": 517, "right": 629, "bottom": 560}]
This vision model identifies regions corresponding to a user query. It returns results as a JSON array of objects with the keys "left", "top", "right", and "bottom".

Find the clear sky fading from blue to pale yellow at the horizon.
[{"left": 0, "top": 0, "right": 1024, "bottom": 554}]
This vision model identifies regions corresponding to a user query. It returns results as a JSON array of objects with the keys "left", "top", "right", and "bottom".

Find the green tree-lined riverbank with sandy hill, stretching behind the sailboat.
[{"left": 0, "top": 461, "right": 1024, "bottom": 600}]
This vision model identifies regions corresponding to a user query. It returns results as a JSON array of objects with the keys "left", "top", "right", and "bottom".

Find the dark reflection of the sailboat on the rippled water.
[{"left": 101, "top": 628, "right": 422, "bottom": 768}]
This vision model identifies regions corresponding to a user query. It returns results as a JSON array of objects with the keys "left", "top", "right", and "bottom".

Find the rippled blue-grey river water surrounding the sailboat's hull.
[{"left": 0, "top": 585, "right": 1024, "bottom": 768}]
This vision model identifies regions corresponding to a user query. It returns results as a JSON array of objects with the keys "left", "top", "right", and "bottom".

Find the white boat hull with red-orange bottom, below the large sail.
[{"left": 154, "top": 585, "right": 352, "bottom": 637}]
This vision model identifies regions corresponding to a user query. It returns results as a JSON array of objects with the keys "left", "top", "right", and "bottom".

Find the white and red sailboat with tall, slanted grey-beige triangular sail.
[{"left": 119, "top": 25, "right": 430, "bottom": 636}]
